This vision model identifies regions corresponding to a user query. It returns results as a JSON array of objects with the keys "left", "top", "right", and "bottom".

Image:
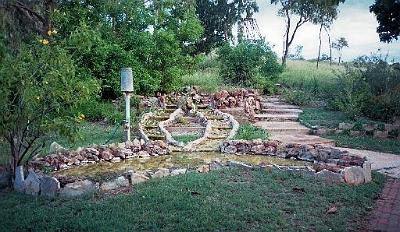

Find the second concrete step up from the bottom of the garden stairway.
[{"left": 254, "top": 121, "right": 310, "bottom": 135}]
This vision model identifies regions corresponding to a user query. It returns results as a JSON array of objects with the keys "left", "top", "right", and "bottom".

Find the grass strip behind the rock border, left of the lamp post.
[{"left": 0, "top": 122, "right": 123, "bottom": 164}]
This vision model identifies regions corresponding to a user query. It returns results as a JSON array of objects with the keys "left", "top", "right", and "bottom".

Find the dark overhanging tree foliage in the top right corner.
[{"left": 369, "top": 0, "right": 400, "bottom": 43}]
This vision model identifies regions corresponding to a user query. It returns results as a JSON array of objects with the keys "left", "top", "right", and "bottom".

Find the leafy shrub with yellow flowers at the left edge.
[{"left": 0, "top": 41, "right": 99, "bottom": 167}]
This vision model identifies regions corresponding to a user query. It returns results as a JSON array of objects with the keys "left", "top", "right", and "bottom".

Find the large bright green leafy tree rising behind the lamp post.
[{"left": 52, "top": 0, "right": 203, "bottom": 96}]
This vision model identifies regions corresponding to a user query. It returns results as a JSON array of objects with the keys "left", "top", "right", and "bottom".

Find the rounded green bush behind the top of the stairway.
[{"left": 218, "top": 41, "right": 282, "bottom": 90}]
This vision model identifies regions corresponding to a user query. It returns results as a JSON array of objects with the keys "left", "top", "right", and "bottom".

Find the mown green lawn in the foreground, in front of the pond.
[{"left": 0, "top": 169, "right": 384, "bottom": 231}]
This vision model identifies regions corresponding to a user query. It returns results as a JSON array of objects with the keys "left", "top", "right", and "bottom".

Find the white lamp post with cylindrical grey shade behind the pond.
[{"left": 121, "top": 68, "right": 133, "bottom": 141}]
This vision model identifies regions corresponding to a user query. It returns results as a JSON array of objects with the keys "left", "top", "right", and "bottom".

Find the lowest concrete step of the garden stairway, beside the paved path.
[{"left": 270, "top": 133, "right": 336, "bottom": 146}]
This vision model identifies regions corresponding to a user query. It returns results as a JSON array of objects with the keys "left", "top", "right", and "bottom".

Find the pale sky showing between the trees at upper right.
[{"left": 254, "top": 0, "right": 400, "bottom": 62}]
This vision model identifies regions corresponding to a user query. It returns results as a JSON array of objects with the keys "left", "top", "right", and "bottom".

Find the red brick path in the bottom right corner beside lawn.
[{"left": 366, "top": 179, "right": 400, "bottom": 232}]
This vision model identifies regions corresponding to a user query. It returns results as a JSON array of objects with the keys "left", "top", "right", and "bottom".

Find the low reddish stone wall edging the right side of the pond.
[{"left": 220, "top": 140, "right": 371, "bottom": 185}]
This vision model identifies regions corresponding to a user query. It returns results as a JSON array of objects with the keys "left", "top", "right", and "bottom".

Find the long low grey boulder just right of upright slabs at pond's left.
[{"left": 60, "top": 180, "right": 98, "bottom": 197}]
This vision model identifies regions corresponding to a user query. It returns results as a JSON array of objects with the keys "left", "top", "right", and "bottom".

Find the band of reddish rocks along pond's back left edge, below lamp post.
[{"left": 28, "top": 139, "right": 170, "bottom": 170}]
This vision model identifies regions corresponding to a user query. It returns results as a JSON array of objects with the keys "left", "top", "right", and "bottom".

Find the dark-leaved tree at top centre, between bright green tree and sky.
[{"left": 196, "top": 0, "right": 258, "bottom": 53}]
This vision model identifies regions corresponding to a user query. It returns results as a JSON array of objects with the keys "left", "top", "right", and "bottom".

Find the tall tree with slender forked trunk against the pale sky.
[{"left": 271, "top": 0, "right": 343, "bottom": 65}]
